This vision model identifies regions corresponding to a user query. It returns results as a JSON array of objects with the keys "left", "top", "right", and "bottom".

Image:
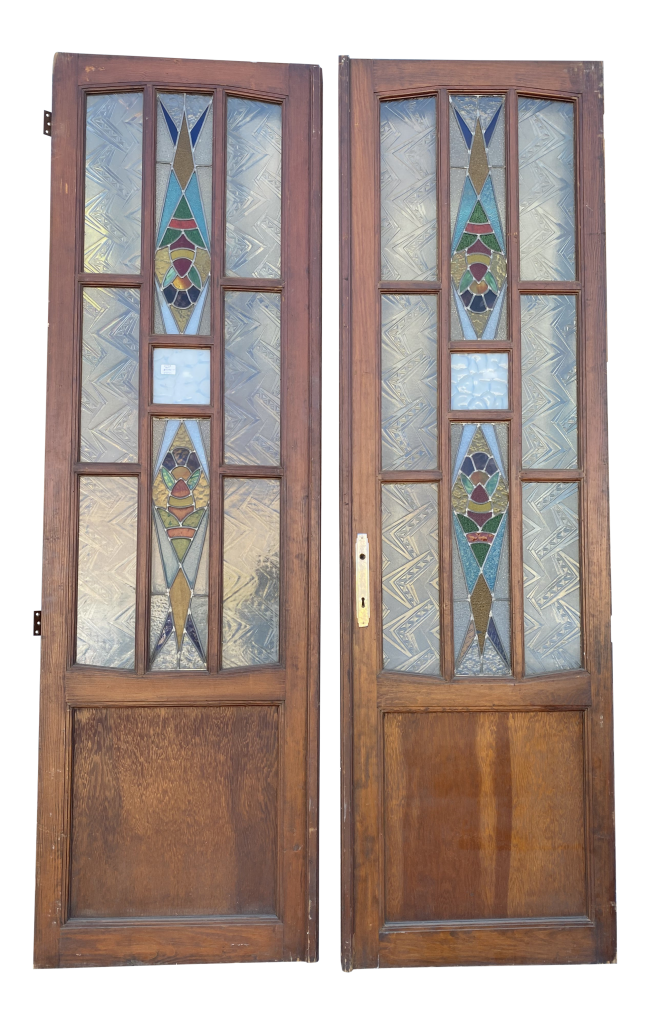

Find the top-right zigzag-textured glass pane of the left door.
[{"left": 225, "top": 96, "right": 283, "bottom": 278}]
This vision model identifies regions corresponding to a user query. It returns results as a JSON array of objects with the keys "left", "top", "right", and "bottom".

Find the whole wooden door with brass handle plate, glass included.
[{"left": 339, "top": 57, "right": 615, "bottom": 971}]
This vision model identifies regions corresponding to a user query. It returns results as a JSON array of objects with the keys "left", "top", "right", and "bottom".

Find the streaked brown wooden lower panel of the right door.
[{"left": 384, "top": 712, "right": 587, "bottom": 921}]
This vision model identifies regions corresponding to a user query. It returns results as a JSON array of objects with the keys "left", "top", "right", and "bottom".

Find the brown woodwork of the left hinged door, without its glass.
[{"left": 35, "top": 53, "right": 321, "bottom": 970}]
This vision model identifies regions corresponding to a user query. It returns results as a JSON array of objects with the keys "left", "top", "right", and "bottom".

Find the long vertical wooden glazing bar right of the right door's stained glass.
[{"left": 506, "top": 89, "right": 524, "bottom": 679}]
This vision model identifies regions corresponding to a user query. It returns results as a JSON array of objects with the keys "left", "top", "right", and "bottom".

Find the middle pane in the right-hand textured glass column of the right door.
[{"left": 521, "top": 295, "right": 577, "bottom": 469}]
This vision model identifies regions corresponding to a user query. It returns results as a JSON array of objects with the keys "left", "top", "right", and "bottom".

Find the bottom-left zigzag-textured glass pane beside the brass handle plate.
[{"left": 382, "top": 483, "right": 440, "bottom": 675}]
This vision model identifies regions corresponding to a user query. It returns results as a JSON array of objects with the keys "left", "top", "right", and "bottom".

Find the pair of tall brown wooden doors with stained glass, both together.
[{"left": 35, "top": 53, "right": 613, "bottom": 970}]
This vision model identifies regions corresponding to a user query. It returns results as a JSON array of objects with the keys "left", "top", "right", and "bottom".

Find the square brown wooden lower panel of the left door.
[{"left": 70, "top": 706, "right": 279, "bottom": 918}]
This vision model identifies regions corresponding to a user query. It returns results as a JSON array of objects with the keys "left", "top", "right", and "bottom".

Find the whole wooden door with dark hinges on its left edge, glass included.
[{"left": 35, "top": 52, "right": 321, "bottom": 970}]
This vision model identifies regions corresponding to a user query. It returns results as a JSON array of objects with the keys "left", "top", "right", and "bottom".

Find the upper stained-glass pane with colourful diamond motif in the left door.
[{"left": 155, "top": 93, "right": 212, "bottom": 335}]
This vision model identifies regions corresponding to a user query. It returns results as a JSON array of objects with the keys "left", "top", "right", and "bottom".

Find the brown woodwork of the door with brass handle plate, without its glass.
[{"left": 339, "top": 56, "right": 615, "bottom": 971}]
